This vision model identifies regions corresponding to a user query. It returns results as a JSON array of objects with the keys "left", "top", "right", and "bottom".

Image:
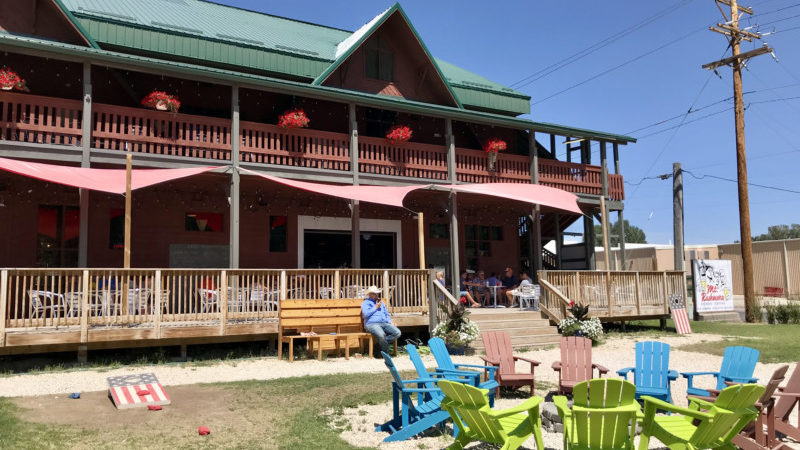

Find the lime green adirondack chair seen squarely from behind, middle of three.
[{"left": 553, "top": 378, "right": 642, "bottom": 450}]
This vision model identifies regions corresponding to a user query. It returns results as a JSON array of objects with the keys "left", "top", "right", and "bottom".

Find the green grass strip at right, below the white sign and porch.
[{"left": 607, "top": 320, "right": 800, "bottom": 363}]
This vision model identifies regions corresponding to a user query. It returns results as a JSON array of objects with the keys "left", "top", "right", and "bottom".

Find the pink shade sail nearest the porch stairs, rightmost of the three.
[{"left": 437, "top": 183, "right": 583, "bottom": 214}]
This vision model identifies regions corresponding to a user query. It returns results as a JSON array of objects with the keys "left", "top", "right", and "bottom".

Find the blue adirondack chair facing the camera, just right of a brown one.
[{"left": 617, "top": 341, "right": 678, "bottom": 403}]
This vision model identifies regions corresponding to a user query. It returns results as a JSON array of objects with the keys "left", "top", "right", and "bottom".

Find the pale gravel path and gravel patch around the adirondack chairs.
[{"left": 0, "top": 334, "right": 800, "bottom": 448}]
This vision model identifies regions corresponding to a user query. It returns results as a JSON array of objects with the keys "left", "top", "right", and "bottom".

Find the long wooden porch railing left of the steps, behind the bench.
[{"left": 0, "top": 269, "right": 429, "bottom": 346}]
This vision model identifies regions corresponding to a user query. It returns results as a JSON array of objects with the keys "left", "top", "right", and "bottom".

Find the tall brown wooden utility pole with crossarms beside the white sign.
[{"left": 703, "top": 0, "right": 772, "bottom": 322}]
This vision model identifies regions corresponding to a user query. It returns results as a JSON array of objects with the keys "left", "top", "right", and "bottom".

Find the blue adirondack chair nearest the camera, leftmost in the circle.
[{"left": 375, "top": 352, "right": 450, "bottom": 442}]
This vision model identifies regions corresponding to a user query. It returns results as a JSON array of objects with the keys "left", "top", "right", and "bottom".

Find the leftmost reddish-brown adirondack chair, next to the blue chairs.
[{"left": 481, "top": 331, "right": 541, "bottom": 398}]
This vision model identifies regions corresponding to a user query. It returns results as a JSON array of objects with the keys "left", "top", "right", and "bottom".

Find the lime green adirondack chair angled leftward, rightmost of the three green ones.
[{"left": 639, "top": 384, "right": 765, "bottom": 450}]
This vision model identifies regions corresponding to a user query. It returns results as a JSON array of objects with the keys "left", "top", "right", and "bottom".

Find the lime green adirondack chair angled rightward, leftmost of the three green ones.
[{"left": 438, "top": 380, "right": 544, "bottom": 450}]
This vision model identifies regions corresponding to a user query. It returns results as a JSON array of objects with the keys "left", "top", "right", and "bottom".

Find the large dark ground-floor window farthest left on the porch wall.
[{"left": 36, "top": 205, "right": 80, "bottom": 267}]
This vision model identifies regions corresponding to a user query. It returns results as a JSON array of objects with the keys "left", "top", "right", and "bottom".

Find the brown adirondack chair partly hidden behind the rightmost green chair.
[{"left": 688, "top": 365, "right": 800, "bottom": 450}]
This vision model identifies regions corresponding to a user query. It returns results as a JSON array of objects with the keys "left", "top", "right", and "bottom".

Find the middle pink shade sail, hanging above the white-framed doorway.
[{"left": 240, "top": 169, "right": 430, "bottom": 207}]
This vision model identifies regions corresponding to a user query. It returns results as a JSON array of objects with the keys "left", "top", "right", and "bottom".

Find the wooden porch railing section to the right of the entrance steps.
[{"left": 539, "top": 270, "right": 686, "bottom": 320}]
